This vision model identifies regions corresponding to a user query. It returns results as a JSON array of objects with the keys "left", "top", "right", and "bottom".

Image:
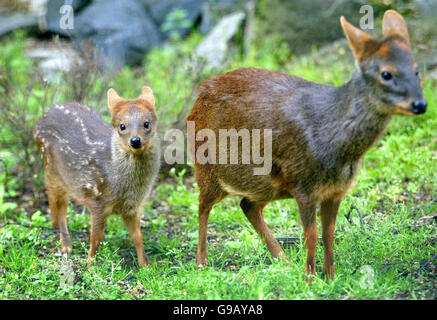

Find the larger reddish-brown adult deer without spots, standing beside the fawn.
[{"left": 188, "top": 10, "right": 427, "bottom": 278}]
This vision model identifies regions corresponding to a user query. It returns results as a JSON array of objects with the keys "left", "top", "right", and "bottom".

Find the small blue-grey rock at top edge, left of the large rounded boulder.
[{"left": 46, "top": 0, "right": 91, "bottom": 37}]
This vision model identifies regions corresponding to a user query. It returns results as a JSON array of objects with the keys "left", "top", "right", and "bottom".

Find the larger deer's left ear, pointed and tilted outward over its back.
[{"left": 340, "top": 16, "right": 376, "bottom": 62}]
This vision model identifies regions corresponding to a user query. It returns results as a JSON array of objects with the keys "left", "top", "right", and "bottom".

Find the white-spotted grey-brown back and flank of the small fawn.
[{"left": 34, "top": 102, "right": 111, "bottom": 200}]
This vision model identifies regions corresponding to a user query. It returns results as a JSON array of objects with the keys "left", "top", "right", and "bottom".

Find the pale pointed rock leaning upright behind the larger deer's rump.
[{"left": 194, "top": 12, "right": 245, "bottom": 68}]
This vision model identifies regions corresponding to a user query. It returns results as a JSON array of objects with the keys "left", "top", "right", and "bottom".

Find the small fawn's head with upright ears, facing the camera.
[{"left": 108, "top": 87, "right": 157, "bottom": 154}]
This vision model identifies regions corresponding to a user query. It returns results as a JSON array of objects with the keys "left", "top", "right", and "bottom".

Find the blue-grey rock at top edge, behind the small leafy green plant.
[{"left": 143, "top": 0, "right": 207, "bottom": 38}]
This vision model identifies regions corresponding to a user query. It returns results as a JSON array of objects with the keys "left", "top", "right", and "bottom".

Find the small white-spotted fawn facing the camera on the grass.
[{"left": 34, "top": 87, "right": 160, "bottom": 266}]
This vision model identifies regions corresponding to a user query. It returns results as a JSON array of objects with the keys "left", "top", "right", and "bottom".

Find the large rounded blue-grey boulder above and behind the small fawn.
[{"left": 74, "top": 0, "right": 161, "bottom": 69}]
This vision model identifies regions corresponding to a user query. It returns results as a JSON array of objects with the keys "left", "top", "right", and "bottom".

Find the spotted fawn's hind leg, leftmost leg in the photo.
[{"left": 47, "top": 189, "right": 71, "bottom": 253}]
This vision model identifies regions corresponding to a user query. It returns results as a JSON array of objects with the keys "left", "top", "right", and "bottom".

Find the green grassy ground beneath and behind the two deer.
[{"left": 0, "top": 31, "right": 437, "bottom": 299}]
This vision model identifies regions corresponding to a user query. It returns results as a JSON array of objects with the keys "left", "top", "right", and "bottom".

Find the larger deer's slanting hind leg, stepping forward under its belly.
[{"left": 240, "top": 198, "right": 290, "bottom": 262}]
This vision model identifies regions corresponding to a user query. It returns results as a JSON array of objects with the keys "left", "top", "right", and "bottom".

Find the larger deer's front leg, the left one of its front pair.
[{"left": 296, "top": 199, "right": 319, "bottom": 274}]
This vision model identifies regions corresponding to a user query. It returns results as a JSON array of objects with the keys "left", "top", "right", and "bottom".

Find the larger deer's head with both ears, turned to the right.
[{"left": 340, "top": 10, "right": 427, "bottom": 116}]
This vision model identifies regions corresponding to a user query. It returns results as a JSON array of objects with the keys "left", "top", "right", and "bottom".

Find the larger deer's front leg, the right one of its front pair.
[{"left": 320, "top": 199, "right": 341, "bottom": 279}]
